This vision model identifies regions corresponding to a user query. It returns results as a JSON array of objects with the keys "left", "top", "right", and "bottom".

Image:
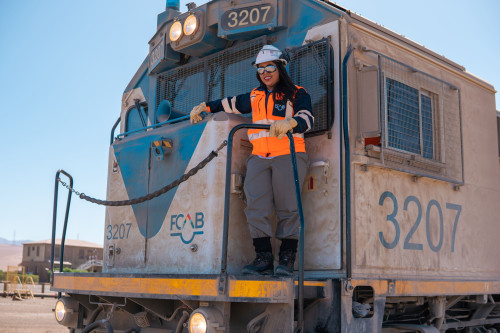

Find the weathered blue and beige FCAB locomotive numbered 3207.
[{"left": 51, "top": 0, "right": 500, "bottom": 333}]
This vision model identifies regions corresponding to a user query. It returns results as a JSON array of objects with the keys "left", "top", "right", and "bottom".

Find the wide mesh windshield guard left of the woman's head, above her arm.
[{"left": 156, "top": 38, "right": 265, "bottom": 114}]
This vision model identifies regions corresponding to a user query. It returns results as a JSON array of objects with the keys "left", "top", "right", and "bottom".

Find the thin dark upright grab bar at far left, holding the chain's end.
[{"left": 50, "top": 169, "right": 73, "bottom": 298}]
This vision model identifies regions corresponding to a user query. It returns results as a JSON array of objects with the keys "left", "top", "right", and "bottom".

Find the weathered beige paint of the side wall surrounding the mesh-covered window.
[{"left": 349, "top": 22, "right": 500, "bottom": 280}]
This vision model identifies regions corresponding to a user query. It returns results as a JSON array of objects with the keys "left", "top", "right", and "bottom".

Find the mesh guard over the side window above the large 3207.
[{"left": 379, "top": 55, "right": 463, "bottom": 181}]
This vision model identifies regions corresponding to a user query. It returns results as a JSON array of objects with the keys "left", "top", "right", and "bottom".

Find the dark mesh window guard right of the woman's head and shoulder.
[{"left": 289, "top": 39, "right": 331, "bottom": 135}]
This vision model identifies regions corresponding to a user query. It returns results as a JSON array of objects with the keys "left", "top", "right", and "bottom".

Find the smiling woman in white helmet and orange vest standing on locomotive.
[{"left": 190, "top": 45, "right": 314, "bottom": 275}]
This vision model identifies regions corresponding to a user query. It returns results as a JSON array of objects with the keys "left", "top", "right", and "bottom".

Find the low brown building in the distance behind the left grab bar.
[{"left": 21, "top": 238, "right": 102, "bottom": 282}]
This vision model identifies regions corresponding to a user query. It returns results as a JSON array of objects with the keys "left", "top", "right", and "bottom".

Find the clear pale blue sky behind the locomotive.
[{"left": 0, "top": 0, "right": 500, "bottom": 244}]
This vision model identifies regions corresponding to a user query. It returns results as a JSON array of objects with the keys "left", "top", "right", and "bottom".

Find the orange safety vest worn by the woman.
[{"left": 248, "top": 86, "right": 306, "bottom": 157}]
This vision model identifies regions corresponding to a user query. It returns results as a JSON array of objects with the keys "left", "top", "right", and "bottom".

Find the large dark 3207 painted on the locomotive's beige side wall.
[{"left": 378, "top": 191, "right": 462, "bottom": 252}]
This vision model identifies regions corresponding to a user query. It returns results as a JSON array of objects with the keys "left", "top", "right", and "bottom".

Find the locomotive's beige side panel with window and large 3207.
[{"left": 349, "top": 23, "right": 500, "bottom": 280}]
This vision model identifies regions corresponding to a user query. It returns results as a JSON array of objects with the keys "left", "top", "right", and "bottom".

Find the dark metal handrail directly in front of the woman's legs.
[{"left": 221, "top": 124, "right": 305, "bottom": 332}]
